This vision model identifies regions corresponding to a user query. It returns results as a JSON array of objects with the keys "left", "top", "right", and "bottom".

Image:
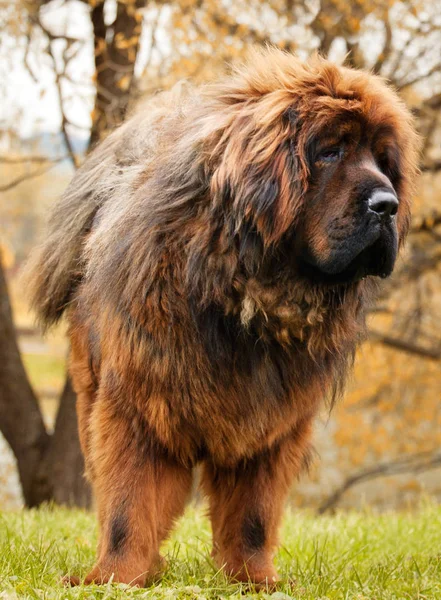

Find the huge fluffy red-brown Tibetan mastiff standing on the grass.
[{"left": 32, "top": 49, "right": 418, "bottom": 585}]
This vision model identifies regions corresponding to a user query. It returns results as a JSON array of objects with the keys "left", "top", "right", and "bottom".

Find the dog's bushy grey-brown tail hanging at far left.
[{"left": 25, "top": 136, "right": 115, "bottom": 329}]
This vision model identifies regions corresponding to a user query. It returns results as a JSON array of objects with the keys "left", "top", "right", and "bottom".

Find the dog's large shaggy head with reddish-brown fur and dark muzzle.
[{"left": 200, "top": 50, "right": 418, "bottom": 284}]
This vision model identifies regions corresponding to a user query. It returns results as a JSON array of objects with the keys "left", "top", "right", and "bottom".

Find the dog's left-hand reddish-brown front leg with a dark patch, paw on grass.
[{"left": 65, "top": 382, "right": 192, "bottom": 586}]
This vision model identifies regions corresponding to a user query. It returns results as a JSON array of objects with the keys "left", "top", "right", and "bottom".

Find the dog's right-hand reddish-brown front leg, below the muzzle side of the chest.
[{"left": 202, "top": 420, "right": 311, "bottom": 586}]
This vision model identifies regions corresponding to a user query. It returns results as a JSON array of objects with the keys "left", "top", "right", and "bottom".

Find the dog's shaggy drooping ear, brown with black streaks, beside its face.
[{"left": 211, "top": 109, "right": 307, "bottom": 248}]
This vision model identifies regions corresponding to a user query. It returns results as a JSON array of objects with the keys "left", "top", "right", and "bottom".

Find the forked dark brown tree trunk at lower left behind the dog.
[{"left": 0, "top": 257, "right": 91, "bottom": 507}]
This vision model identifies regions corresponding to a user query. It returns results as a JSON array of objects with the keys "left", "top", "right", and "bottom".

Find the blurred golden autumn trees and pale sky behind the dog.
[{"left": 0, "top": 0, "right": 441, "bottom": 512}]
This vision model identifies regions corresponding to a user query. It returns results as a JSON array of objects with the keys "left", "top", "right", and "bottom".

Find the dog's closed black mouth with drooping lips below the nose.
[{"left": 300, "top": 221, "right": 398, "bottom": 285}]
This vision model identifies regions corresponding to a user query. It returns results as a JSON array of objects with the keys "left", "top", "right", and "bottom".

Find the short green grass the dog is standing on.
[{"left": 0, "top": 503, "right": 441, "bottom": 600}]
